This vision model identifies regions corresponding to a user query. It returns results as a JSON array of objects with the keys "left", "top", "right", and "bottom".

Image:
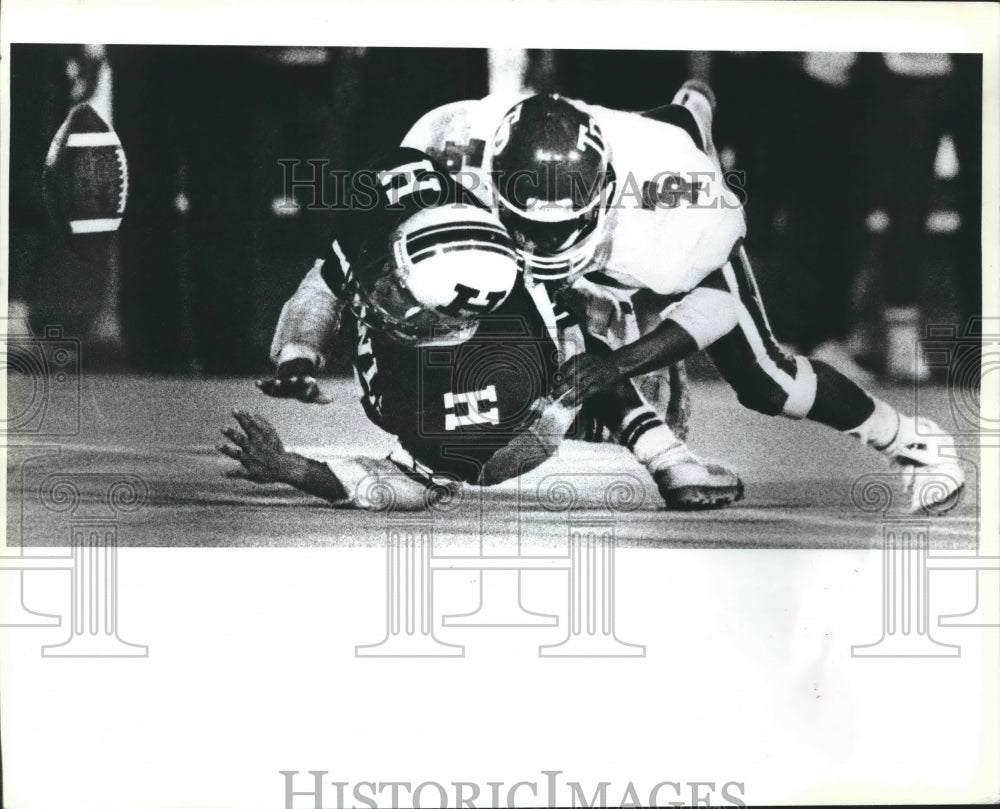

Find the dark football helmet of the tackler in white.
[{"left": 490, "top": 95, "right": 614, "bottom": 280}]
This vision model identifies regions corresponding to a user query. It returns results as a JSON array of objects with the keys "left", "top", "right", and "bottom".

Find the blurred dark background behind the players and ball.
[{"left": 8, "top": 44, "right": 982, "bottom": 379}]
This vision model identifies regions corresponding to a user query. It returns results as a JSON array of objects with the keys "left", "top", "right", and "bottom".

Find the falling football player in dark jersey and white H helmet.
[{"left": 219, "top": 149, "right": 576, "bottom": 508}]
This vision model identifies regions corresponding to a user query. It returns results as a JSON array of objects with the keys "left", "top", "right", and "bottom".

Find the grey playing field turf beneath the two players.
[{"left": 7, "top": 375, "right": 978, "bottom": 548}]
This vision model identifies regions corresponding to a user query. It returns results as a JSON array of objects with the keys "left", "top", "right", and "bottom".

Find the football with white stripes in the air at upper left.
[{"left": 43, "top": 104, "right": 128, "bottom": 260}]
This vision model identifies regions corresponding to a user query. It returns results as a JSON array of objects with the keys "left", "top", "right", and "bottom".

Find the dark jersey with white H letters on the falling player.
[{"left": 314, "top": 149, "right": 559, "bottom": 482}]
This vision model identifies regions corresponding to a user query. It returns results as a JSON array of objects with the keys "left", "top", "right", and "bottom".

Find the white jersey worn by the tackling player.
[{"left": 402, "top": 94, "right": 746, "bottom": 295}]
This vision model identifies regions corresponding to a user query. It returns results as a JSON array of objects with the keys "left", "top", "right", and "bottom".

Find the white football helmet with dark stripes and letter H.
[{"left": 348, "top": 204, "right": 519, "bottom": 341}]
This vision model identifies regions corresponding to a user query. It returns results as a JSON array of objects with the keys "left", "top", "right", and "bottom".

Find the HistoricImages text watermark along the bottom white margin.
[{"left": 278, "top": 770, "right": 747, "bottom": 809}]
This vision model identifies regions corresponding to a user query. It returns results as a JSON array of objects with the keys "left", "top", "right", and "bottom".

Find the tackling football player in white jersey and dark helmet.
[{"left": 404, "top": 81, "right": 964, "bottom": 513}]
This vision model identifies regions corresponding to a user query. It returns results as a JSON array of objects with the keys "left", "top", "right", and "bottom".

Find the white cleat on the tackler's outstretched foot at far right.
[{"left": 882, "top": 416, "right": 965, "bottom": 516}]
